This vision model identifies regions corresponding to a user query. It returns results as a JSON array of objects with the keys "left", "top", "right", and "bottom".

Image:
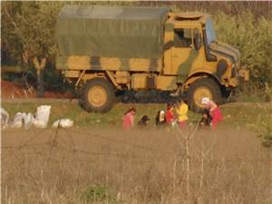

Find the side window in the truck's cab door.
[{"left": 174, "top": 29, "right": 192, "bottom": 47}]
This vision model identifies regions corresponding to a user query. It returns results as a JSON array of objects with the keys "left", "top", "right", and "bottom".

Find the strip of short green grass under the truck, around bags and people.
[{"left": 2, "top": 99, "right": 272, "bottom": 130}]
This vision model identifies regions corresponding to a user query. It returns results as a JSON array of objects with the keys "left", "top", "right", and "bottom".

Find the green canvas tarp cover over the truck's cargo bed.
[{"left": 57, "top": 5, "right": 168, "bottom": 58}]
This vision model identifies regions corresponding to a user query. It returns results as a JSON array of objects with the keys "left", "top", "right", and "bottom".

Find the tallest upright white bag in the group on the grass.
[{"left": 33, "top": 105, "right": 51, "bottom": 128}]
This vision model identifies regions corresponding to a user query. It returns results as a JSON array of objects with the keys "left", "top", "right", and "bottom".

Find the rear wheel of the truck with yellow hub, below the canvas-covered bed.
[{"left": 82, "top": 78, "right": 115, "bottom": 113}]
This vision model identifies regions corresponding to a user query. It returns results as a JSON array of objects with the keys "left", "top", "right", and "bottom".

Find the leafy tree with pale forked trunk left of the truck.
[{"left": 1, "top": 2, "right": 62, "bottom": 97}]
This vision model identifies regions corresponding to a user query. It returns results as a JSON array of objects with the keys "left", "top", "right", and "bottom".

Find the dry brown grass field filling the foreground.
[{"left": 2, "top": 127, "right": 272, "bottom": 204}]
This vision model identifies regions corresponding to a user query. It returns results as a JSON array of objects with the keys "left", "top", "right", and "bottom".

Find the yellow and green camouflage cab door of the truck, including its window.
[{"left": 168, "top": 28, "right": 204, "bottom": 83}]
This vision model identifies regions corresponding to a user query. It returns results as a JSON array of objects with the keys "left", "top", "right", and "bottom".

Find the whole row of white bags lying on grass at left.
[{"left": 0, "top": 105, "right": 74, "bottom": 129}]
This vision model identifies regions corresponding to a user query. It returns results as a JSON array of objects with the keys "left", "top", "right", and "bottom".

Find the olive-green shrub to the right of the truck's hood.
[{"left": 213, "top": 11, "right": 272, "bottom": 90}]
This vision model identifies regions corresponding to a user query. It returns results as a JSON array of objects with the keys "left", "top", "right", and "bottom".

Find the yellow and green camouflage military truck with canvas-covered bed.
[{"left": 56, "top": 5, "right": 248, "bottom": 112}]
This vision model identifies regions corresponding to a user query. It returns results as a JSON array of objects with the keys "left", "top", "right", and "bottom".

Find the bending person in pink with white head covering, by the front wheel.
[{"left": 201, "top": 97, "right": 223, "bottom": 130}]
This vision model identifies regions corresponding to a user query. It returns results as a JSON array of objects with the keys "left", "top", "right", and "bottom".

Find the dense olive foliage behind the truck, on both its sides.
[{"left": 1, "top": 1, "right": 272, "bottom": 98}]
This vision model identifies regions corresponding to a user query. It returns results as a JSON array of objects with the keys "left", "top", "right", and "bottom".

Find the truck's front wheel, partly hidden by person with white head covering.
[{"left": 187, "top": 78, "right": 222, "bottom": 113}]
